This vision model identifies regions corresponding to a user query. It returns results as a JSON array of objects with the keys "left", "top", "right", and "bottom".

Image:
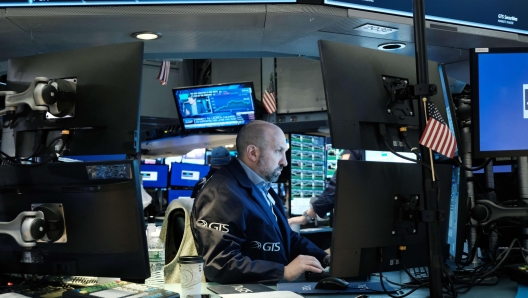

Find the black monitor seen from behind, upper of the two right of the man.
[{"left": 319, "top": 40, "right": 446, "bottom": 152}]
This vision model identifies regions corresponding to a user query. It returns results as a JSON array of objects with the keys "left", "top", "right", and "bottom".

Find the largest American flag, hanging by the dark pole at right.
[{"left": 420, "top": 102, "right": 456, "bottom": 158}]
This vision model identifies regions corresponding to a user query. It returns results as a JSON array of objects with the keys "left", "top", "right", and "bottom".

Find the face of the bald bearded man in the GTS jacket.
[{"left": 257, "top": 128, "right": 288, "bottom": 182}]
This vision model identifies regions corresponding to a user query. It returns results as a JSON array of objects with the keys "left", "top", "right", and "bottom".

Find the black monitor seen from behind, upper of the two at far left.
[{"left": 2, "top": 42, "right": 143, "bottom": 157}]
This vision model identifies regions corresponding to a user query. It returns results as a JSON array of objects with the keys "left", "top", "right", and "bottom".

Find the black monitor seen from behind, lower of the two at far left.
[{"left": 0, "top": 160, "right": 150, "bottom": 280}]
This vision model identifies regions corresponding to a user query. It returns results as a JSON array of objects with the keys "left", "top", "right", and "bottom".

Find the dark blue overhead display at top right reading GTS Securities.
[{"left": 324, "top": 0, "right": 528, "bottom": 34}]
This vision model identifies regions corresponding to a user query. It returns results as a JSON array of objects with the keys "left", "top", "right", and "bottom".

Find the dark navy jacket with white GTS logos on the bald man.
[{"left": 191, "top": 159, "right": 326, "bottom": 283}]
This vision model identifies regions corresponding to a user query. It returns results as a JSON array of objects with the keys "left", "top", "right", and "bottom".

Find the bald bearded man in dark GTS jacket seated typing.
[{"left": 192, "top": 120, "right": 329, "bottom": 283}]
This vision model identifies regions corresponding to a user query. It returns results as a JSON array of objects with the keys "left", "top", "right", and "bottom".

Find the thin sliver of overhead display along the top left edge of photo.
[{"left": 0, "top": 0, "right": 296, "bottom": 7}]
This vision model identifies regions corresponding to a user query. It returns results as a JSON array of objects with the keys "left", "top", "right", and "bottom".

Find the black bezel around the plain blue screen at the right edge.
[{"left": 469, "top": 47, "right": 528, "bottom": 158}]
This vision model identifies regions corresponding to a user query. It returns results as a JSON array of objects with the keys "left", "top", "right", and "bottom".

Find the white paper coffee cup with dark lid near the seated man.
[{"left": 178, "top": 256, "right": 203, "bottom": 297}]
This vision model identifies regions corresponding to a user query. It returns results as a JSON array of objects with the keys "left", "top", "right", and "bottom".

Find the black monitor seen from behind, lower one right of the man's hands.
[{"left": 330, "top": 160, "right": 451, "bottom": 278}]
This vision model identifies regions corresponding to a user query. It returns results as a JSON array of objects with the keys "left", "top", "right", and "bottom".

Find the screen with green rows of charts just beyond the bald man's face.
[{"left": 289, "top": 134, "right": 326, "bottom": 216}]
